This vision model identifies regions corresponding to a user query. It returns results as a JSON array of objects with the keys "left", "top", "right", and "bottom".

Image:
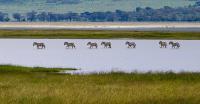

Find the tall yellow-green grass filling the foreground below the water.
[{"left": 0, "top": 72, "right": 200, "bottom": 104}]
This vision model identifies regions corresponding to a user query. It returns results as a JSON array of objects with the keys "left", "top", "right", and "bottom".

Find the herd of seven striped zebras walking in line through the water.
[{"left": 33, "top": 41, "right": 180, "bottom": 49}]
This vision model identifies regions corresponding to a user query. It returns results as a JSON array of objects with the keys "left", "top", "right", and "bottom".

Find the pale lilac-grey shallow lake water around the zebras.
[{"left": 0, "top": 39, "right": 200, "bottom": 73}]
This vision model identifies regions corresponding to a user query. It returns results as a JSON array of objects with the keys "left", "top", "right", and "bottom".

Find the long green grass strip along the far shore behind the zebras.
[{"left": 0, "top": 30, "right": 200, "bottom": 40}]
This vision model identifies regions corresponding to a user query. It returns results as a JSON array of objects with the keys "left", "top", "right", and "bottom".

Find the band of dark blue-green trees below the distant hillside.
[{"left": 0, "top": 0, "right": 200, "bottom": 22}]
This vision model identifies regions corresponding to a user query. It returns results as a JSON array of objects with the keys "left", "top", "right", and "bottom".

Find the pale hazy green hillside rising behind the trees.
[{"left": 0, "top": 0, "right": 196, "bottom": 13}]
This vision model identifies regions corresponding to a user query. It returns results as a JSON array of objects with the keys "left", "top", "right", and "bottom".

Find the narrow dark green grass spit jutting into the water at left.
[{"left": 0, "top": 65, "right": 75, "bottom": 73}]
